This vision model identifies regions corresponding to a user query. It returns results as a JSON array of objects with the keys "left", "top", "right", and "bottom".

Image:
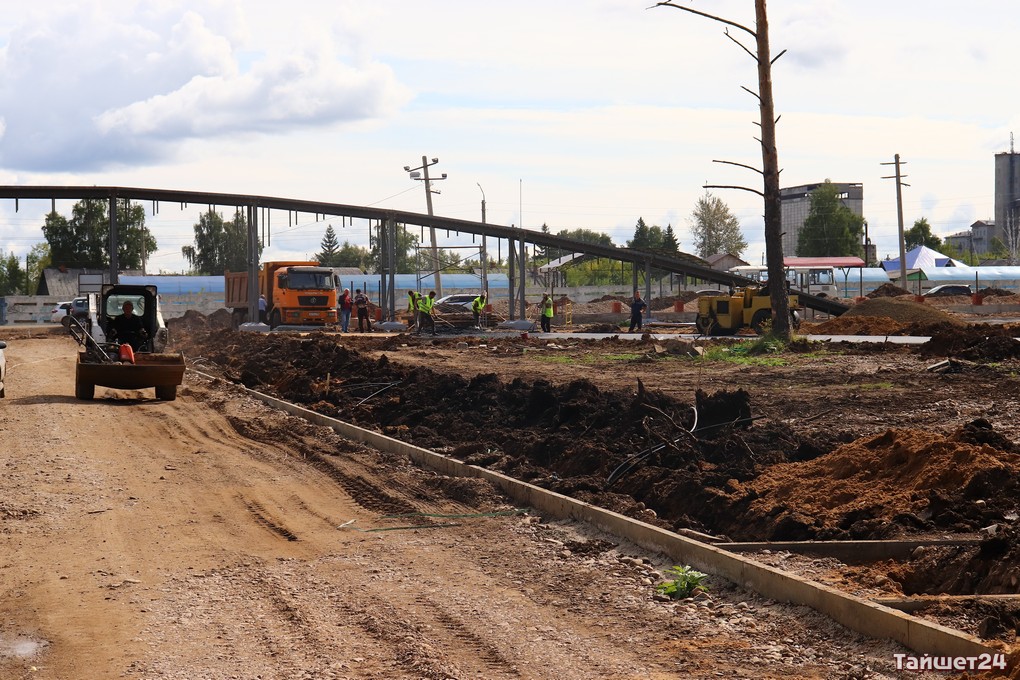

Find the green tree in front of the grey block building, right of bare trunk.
[{"left": 797, "top": 179, "right": 864, "bottom": 257}]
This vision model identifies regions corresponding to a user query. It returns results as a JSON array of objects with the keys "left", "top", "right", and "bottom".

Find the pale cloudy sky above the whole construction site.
[{"left": 0, "top": 0, "right": 1020, "bottom": 271}]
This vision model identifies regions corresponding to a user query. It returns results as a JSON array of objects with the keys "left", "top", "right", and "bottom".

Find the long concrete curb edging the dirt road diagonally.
[{"left": 189, "top": 367, "right": 1003, "bottom": 657}]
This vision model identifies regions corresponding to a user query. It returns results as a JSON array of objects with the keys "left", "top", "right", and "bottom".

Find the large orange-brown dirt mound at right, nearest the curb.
[{"left": 741, "top": 420, "right": 1020, "bottom": 540}]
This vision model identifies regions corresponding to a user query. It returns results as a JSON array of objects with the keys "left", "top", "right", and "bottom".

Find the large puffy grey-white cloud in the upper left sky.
[{"left": 0, "top": 2, "right": 409, "bottom": 171}]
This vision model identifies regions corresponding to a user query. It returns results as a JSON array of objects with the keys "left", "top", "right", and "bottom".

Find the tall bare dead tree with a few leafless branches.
[{"left": 655, "top": 0, "right": 792, "bottom": 339}]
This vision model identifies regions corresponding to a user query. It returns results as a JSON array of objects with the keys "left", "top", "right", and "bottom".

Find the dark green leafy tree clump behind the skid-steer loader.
[{"left": 43, "top": 199, "right": 156, "bottom": 269}]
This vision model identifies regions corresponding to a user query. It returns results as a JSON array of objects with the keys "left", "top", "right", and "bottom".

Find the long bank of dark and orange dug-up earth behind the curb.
[{"left": 177, "top": 316, "right": 1020, "bottom": 637}]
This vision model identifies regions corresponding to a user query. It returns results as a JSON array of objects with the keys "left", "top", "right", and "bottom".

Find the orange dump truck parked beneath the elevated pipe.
[{"left": 223, "top": 262, "right": 338, "bottom": 328}]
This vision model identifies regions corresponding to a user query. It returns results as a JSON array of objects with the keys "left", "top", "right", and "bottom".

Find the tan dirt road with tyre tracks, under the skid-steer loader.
[{"left": 0, "top": 332, "right": 946, "bottom": 680}]
